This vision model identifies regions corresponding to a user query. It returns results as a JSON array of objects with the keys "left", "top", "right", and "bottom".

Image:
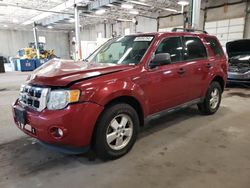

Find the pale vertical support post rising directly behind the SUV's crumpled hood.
[{"left": 74, "top": 4, "right": 82, "bottom": 60}]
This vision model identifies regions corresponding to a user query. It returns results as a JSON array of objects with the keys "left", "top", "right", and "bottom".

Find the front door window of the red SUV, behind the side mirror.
[{"left": 155, "top": 37, "right": 183, "bottom": 62}]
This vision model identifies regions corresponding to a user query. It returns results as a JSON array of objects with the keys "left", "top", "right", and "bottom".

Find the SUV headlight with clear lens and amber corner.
[{"left": 47, "top": 90, "right": 80, "bottom": 110}]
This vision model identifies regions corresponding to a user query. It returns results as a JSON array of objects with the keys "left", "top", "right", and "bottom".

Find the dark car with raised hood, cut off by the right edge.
[{"left": 226, "top": 39, "right": 250, "bottom": 83}]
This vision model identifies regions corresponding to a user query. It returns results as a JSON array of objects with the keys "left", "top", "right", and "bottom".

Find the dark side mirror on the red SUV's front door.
[{"left": 149, "top": 53, "right": 171, "bottom": 69}]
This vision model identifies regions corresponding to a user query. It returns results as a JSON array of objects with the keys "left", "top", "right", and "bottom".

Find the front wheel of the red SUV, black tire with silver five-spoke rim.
[{"left": 93, "top": 103, "right": 139, "bottom": 160}]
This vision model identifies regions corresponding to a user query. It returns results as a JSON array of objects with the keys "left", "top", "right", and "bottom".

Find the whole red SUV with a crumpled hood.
[{"left": 13, "top": 29, "right": 227, "bottom": 159}]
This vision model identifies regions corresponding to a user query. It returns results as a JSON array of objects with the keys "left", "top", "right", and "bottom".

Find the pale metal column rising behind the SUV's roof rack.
[{"left": 190, "top": 0, "right": 201, "bottom": 29}]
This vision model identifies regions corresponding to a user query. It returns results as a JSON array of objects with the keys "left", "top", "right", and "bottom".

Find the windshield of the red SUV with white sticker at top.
[{"left": 87, "top": 35, "right": 154, "bottom": 65}]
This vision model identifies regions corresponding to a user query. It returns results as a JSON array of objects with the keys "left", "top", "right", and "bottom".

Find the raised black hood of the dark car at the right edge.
[{"left": 226, "top": 39, "right": 250, "bottom": 58}]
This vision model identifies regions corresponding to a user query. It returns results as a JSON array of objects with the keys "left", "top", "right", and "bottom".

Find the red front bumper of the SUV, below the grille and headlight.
[{"left": 12, "top": 100, "right": 103, "bottom": 148}]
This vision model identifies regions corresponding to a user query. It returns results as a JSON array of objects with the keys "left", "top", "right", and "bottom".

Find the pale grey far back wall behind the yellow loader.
[{"left": 0, "top": 30, "right": 69, "bottom": 59}]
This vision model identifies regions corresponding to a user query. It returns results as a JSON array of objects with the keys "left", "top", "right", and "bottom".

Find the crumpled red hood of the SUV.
[{"left": 27, "top": 59, "right": 131, "bottom": 86}]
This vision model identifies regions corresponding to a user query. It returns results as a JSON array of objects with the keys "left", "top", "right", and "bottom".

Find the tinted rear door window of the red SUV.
[{"left": 184, "top": 37, "right": 207, "bottom": 60}]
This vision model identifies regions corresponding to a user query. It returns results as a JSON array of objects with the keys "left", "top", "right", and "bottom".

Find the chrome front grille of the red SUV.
[{"left": 19, "top": 85, "right": 50, "bottom": 112}]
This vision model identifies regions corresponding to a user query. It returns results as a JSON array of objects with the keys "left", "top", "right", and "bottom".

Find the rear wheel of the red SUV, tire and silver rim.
[{"left": 198, "top": 81, "right": 222, "bottom": 115}]
